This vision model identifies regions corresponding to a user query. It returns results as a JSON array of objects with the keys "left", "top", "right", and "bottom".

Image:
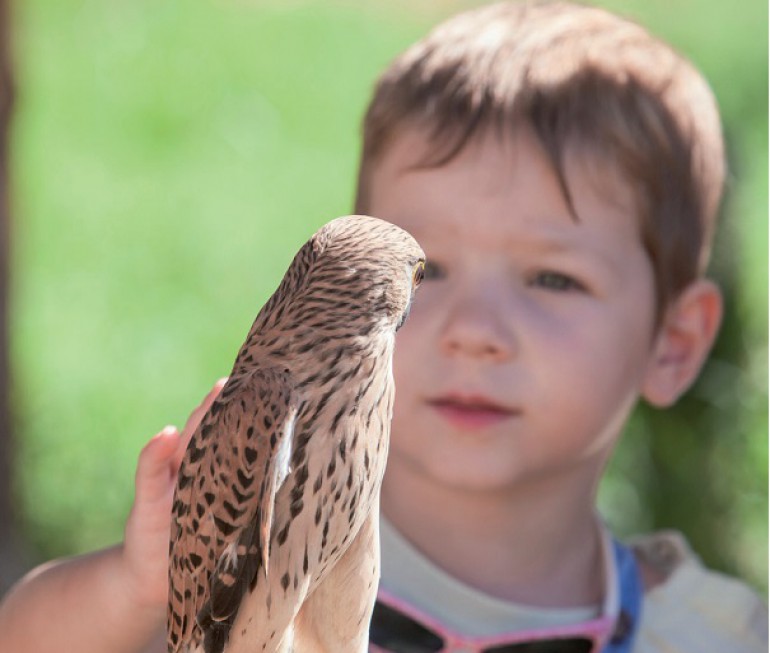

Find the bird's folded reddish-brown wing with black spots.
[{"left": 168, "top": 369, "right": 297, "bottom": 651}]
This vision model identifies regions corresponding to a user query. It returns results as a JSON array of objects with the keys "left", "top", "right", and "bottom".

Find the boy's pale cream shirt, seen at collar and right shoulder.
[{"left": 380, "top": 518, "right": 768, "bottom": 653}]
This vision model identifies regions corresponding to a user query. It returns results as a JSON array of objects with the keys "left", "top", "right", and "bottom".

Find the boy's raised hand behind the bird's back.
[{"left": 121, "top": 379, "right": 227, "bottom": 609}]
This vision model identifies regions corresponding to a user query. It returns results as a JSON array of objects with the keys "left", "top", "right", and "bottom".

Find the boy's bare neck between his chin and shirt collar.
[{"left": 382, "top": 465, "right": 604, "bottom": 607}]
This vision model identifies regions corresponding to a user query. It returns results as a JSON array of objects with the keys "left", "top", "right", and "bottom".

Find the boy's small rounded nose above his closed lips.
[{"left": 440, "top": 295, "right": 516, "bottom": 363}]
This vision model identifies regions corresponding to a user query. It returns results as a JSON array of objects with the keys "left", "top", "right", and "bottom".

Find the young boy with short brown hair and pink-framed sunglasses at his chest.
[{"left": 0, "top": 3, "right": 767, "bottom": 653}]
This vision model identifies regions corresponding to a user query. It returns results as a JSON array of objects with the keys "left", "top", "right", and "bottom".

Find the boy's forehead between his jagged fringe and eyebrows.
[{"left": 368, "top": 125, "right": 639, "bottom": 226}]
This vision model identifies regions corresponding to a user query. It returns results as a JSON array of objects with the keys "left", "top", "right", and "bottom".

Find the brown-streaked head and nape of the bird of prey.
[{"left": 239, "top": 215, "right": 425, "bottom": 366}]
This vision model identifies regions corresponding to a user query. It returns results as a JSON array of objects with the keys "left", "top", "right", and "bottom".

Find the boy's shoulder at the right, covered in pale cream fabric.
[{"left": 629, "top": 531, "right": 768, "bottom": 653}]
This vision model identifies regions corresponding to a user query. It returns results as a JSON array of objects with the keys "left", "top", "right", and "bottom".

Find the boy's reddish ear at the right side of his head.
[{"left": 642, "top": 279, "right": 722, "bottom": 408}]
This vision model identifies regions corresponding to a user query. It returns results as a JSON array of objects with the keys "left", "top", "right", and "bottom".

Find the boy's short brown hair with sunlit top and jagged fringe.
[{"left": 356, "top": 2, "right": 725, "bottom": 314}]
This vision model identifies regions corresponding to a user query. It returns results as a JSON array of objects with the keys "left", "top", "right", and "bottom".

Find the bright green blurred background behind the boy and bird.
[{"left": 6, "top": 0, "right": 768, "bottom": 592}]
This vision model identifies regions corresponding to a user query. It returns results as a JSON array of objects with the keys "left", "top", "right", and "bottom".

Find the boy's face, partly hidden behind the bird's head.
[{"left": 367, "top": 128, "right": 655, "bottom": 494}]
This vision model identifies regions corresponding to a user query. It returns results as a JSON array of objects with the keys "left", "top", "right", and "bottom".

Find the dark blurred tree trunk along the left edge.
[{"left": 0, "top": 0, "right": 22, "bottom": 591}]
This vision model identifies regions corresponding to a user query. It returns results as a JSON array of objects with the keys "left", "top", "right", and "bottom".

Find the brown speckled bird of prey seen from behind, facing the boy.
[{"left": 167, "top": 215, "right": 425, "bottom": 653}]
